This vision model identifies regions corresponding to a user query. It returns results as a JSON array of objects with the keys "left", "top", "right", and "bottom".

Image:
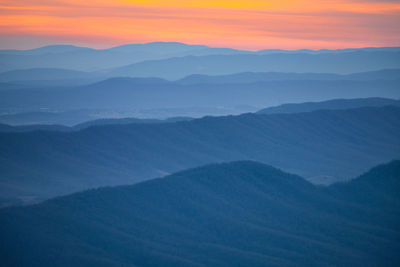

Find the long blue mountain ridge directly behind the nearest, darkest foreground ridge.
[{"left": 0, "top": 107, "right": 400, "bottom": 205}]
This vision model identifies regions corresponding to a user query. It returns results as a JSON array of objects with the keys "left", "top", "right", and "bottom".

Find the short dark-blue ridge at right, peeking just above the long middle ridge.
[{"left": 257, "top": 97, "right": 400, "bottom": 114}]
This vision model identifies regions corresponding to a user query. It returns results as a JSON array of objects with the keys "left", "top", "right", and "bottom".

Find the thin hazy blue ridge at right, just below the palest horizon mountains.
[{"left": 178, "top": 69, "right": 400, "bottom": 84}]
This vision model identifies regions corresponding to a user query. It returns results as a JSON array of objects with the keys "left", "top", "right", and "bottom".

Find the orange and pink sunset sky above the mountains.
[{"left": 0, "top": 0, "right": 400, "bottom": 50}]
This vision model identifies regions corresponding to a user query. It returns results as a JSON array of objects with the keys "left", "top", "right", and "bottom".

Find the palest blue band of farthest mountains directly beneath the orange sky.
[{"left": 0, "top": 42, "right": 400, "bottom": 76}]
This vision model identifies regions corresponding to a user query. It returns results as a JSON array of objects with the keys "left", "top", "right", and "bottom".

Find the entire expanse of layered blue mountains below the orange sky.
[{"left": 0, "top": 41, "right": 400, "bottom": 267}]
